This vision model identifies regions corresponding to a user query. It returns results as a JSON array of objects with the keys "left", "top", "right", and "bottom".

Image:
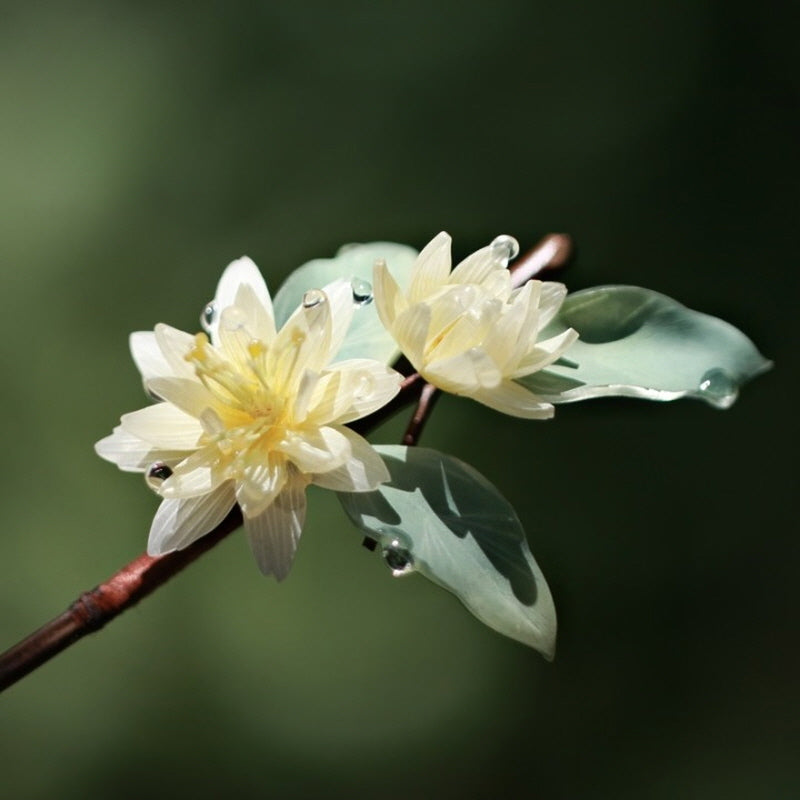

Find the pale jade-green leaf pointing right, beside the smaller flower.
[{"left": 519, "top": 286, "right": 771, "bottom": 408}]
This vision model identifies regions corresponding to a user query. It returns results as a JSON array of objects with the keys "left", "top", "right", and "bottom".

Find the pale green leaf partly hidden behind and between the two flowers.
[{"left": 273, "top": 242, "right": 417, "bottom": 364}]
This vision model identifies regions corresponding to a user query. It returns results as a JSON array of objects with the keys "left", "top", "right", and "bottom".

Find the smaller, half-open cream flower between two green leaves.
[{"left": 374, "top": 233, "right": 578, "bottom": 419}]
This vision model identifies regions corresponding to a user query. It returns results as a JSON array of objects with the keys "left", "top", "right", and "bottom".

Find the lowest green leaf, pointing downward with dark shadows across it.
[{"left": 339, "top": 445, "right": 556, "bottom": 659}]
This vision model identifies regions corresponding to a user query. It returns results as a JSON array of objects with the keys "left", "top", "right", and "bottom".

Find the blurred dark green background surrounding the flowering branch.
[{"left": 0, "top": 0, "right": 800, "bottom": 800}]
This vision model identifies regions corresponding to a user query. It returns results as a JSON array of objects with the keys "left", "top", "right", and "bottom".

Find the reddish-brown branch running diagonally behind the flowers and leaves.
[{"left": 0, "top": 234, "right": 572, "bottom": 691}]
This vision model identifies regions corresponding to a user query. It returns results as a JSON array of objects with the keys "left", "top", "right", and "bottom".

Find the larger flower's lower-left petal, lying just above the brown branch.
[{"left": 147, "top": 481, "right": 236, "bottom": 556}]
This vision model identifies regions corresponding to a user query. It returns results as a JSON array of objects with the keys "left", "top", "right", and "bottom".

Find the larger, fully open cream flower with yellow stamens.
[{"left": 95, "top": 258, "right": 401, "bottom": 580}]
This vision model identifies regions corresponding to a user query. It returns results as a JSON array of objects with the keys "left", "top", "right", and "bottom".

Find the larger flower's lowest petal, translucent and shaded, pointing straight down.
[{"left": 244, "top": 476, "right": 306, "bottom": 581}]
